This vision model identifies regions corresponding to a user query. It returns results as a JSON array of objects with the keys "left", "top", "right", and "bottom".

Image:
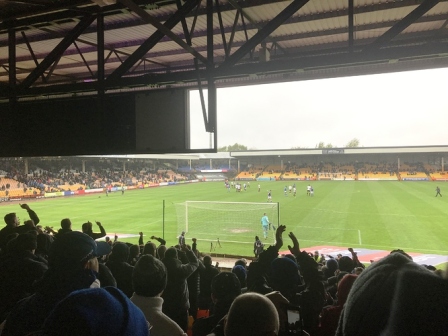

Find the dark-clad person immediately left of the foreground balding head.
[{"left": 193, "top": 272, "right": 241, "bottom": 336}]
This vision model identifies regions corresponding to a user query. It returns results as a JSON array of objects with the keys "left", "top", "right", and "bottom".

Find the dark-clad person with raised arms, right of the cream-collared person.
[{"left": 162, "top": 245, "right": 199, "bottom": 331}]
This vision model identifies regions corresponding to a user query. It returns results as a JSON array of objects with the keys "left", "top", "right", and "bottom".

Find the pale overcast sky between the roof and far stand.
[{"left": 190, "top": 69, "right": 448, "bottom": 149}]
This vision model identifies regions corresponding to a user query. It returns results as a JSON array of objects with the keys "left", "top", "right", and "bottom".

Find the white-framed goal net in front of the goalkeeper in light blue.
[{"left": 175, "top": 201, "right": 279, "bottom": 244}]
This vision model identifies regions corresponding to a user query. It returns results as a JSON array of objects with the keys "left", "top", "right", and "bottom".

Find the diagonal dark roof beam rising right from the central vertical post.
[{"left": 219, "top": 0, "right": 308, "bottom": 69}]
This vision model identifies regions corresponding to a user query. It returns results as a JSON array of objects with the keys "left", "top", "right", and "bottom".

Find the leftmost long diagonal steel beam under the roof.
[{"left": 18, "top": 15, "right": 95, "bottom": 90}]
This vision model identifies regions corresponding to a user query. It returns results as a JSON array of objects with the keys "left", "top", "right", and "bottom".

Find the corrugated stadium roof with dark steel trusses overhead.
[{"left": 0, "top": 0, "right": 448, "bottom": 99}]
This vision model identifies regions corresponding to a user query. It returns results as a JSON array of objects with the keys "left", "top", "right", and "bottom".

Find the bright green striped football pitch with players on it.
[{"left": 0, "top": 181, "right": 448, "bottom": 256}]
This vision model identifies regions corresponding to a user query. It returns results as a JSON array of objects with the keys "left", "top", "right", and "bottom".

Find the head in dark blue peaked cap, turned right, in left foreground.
[{"left": 48, "top": 231, "right": 110, "bottom": 269}]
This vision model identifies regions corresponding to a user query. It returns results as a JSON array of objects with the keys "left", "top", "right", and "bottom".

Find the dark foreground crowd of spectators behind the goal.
[{"left": 0, "top": 204, "right": 448, "bottom": 336}]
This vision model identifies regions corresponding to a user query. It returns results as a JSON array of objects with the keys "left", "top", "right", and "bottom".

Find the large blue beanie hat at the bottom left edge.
[{"left": 43, "top": 287, "right": 149, "bottom": 336}]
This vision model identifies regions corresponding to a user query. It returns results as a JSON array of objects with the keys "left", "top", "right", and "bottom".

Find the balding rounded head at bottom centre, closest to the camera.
[{"left": 224, "top": 293, "right": 280, "bottom": 336}]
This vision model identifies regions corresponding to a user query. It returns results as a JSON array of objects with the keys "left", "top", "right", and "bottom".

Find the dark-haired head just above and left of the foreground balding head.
[{"left": 211, "top": 272, "right": 241, "bottom": 303}]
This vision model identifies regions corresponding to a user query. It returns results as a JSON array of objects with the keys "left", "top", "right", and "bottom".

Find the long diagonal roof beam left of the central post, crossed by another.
[{"left": 106, "top": 0, "right": 198, "bottom": 81}]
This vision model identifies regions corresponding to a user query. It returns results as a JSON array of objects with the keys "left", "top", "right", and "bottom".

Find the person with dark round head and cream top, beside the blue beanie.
[{"left": 131, "top": 255, "right": 186, "bottom": 336}]
